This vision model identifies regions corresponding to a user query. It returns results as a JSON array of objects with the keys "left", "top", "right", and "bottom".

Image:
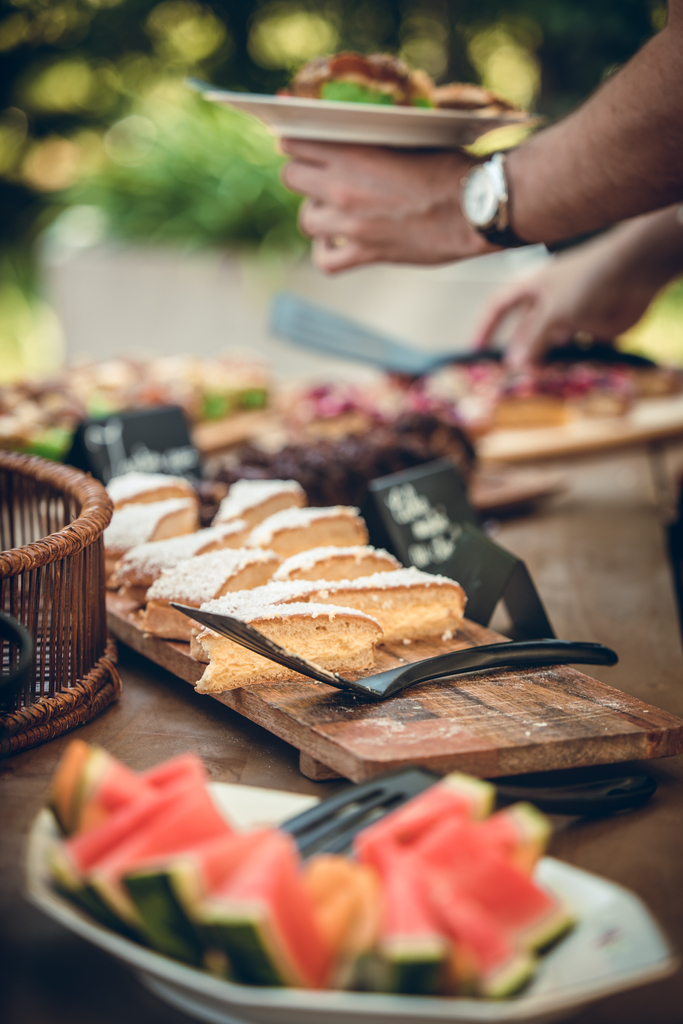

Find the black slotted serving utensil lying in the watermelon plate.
[{"left": 280, "top": 768, "right": 656, "bottom": 857}]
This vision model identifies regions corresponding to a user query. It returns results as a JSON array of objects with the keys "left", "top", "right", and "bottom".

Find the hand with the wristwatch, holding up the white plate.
[{"left": 281, "top": 139, "right": 495, "bottom": 273}]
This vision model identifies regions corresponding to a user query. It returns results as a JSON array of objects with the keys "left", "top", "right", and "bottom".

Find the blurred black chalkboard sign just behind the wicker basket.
[{"left": 66, "top": 406, "right": 201, "bottom": 483}]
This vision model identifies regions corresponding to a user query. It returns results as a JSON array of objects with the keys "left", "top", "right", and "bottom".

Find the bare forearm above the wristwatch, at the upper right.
[{"left": 506, "top": 0, "right": 683, "bottom": 243}]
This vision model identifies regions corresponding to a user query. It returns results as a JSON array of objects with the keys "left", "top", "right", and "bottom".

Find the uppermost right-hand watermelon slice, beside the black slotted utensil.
[{"left": 354, "top": 772, "right": 496, "bottom": 863}]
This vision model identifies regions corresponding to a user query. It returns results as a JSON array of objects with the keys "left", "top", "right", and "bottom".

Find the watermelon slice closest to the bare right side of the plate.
[{"left": 415, "top": 819, "right": 572, "bottom": 949}]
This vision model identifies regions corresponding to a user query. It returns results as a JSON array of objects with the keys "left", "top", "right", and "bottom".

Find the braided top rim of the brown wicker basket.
[{"left": 0, "top": 450, "right": 114, "bottom": 579}]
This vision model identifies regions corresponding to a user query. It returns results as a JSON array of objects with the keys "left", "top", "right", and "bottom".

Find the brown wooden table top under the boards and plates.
[{"left": 0, "top": 451, "right": 683, "bottom": 1024}]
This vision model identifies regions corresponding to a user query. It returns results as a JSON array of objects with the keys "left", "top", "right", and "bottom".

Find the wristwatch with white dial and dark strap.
[{"left": 461, "top": 153, "right": 528, "bottom": 249}]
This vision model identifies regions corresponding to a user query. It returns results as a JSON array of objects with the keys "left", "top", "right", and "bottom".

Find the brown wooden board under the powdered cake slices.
[{"left": 106, "top": 594, "right": 683, "bottom": 782}]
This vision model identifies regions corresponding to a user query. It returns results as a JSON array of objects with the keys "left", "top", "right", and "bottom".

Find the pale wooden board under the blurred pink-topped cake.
[{"left": 476, "top": 394, "right": 683, "bottom": 463}]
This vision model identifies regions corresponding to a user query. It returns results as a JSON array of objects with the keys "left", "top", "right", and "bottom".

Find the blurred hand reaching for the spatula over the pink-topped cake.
[{"left": 474, "top": 215, "right": 668, "bottom": 370}]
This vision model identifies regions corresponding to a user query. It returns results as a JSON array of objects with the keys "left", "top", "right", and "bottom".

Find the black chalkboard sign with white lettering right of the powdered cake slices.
[{"left": 362, "top": 459, "right": 478, "bottom": 575}]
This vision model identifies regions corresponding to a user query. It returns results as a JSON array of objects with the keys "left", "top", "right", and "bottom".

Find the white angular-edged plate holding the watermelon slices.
[{"left": 26, "top": 783, "right": 678, "bottom": 1024}]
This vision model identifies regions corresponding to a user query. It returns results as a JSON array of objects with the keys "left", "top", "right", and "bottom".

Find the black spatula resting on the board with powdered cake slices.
[{"left": 171, "top": 601, "right": 618, "bottom": 700}]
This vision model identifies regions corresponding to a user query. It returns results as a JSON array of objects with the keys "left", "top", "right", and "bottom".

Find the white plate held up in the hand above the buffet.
[{"left": 188, "top": 79, "right": 535, "bottom": 148}]
